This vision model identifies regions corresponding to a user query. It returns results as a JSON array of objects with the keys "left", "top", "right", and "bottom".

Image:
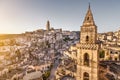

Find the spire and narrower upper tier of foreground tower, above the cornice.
[{"left": 80, "top": 4, "right": 97, "bottom": 43}]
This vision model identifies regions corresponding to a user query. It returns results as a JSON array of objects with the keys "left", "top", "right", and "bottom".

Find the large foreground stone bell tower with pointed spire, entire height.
[{"left": 76, "top": 4, "right": 99, "bottom": 80}]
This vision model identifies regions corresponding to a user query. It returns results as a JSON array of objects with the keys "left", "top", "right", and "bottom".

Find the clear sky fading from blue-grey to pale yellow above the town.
[{"left": 0, "top": 0, "right": 120, "bottom": 34}]
